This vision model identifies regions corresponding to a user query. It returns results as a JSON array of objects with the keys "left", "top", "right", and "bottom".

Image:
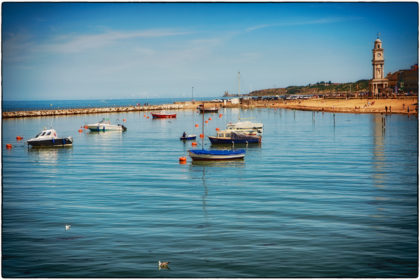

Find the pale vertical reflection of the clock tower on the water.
[{"left": 372, "top": 114, "right": 386, "bottom": 188}]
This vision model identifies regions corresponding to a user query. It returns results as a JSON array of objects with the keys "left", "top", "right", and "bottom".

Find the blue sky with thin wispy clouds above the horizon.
[{"left": 2, "top": 2, "right": 418, "bottom": 100}]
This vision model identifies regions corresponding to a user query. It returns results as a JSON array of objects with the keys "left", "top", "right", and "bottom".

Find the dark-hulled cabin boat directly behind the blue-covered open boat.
[{"left": 209, "top": 130, "right": 262, "bottom": 144}]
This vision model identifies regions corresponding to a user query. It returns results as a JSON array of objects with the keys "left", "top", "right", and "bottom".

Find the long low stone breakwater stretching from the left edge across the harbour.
[{"left": 2, "top": 103, "right": 192, "bottom": 118}]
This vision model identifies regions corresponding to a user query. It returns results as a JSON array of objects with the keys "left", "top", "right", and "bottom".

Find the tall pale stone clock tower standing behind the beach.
[{"left": 369, "top": 37, "right": 388, "bottom": 95}]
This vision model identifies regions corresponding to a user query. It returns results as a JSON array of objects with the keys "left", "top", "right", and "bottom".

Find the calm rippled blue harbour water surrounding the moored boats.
[{"left": 2, "top": 105, "right": 418, "bottom": 278}]
